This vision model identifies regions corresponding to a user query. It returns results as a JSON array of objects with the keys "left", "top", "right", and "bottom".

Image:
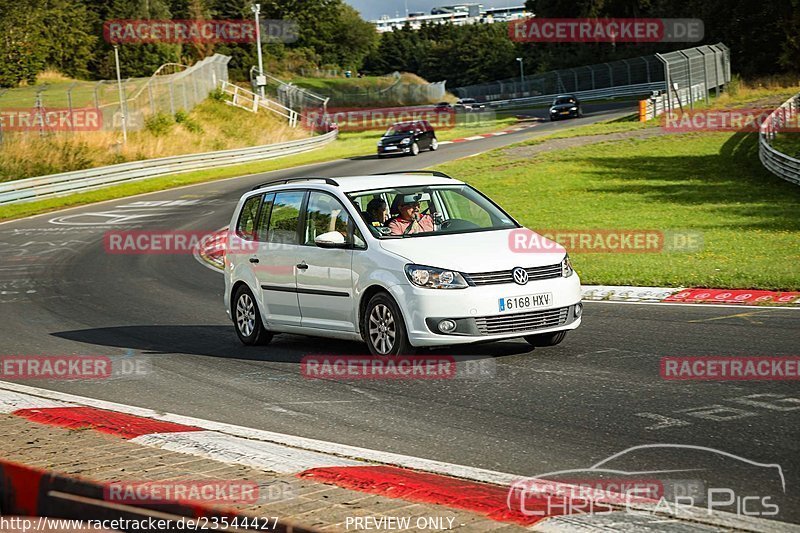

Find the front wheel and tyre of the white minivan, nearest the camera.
[{"left": 361, "top": 292, "right": 414, "bottom": 355}]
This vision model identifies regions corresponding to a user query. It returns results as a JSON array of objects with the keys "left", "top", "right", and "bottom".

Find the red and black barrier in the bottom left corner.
[{"left": 0, "top": 459, "right": 317, "bottom": 533}]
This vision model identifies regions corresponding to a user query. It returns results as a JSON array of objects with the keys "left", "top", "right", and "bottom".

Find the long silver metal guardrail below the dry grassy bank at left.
[{"left": 0, "top": 131, "right": 338, "bottom": 206}]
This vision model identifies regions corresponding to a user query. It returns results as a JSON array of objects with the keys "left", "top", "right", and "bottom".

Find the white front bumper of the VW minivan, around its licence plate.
[{"left": 391, "top": 274, "right": 581, "bottom": 346}]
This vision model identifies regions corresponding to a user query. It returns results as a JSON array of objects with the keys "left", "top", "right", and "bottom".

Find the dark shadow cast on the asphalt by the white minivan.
[{"left": 52, "top": 325, "right": 531, "bottom": 363}]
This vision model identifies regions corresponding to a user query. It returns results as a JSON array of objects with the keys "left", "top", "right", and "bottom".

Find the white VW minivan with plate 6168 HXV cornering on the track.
[{"left": 225, "top": 171, "right": 582, "bottom": 355}]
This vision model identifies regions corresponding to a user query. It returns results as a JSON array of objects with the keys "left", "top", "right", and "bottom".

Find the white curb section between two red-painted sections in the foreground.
[{"left": 130, "top": 431, "right": 368, "bottom": 474}]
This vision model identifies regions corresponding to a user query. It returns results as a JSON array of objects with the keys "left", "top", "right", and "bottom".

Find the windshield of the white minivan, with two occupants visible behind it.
[{"left": 348, "top": 184, "right": 519, "bottom": 238}]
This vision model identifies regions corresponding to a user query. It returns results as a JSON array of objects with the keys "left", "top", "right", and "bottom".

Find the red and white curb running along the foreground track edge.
[{"left": 0, "top": 382, "right": 800, "bottom": 532}]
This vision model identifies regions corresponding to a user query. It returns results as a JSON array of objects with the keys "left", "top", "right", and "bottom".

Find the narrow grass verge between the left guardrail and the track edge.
[{"left": 0, "top": 118, "right": 516, "bottom": 221}]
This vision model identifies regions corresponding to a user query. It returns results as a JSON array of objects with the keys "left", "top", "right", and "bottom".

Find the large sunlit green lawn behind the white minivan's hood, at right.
[{"left": 437, "top": 133, "right": 800, "bottom": 290}]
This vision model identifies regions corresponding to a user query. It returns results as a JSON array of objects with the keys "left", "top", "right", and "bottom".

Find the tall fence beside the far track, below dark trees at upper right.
[{"left": 452, "top": 44, "right": 730, "bottom": 105}]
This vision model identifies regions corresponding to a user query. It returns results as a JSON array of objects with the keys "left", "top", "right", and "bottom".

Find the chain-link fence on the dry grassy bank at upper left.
[{"left": 0, "top": 54, "right": 230, "bottom": 137}]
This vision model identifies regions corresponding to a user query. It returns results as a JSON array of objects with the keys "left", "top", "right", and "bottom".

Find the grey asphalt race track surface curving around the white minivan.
[{"left": 0, "top": 106, "right": 800, "bottom": 522}]
